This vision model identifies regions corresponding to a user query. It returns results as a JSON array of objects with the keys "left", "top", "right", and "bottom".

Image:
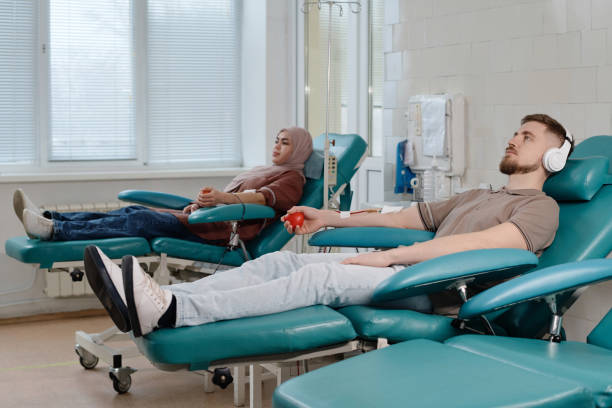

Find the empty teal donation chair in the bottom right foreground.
[{"left": 273, "top": 259, "right": 612, "bottom": 408}]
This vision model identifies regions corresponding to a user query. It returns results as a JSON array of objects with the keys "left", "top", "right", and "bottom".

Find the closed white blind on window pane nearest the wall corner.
[{"left": 147, "top": 0, "right": 242, "bottom": 167}]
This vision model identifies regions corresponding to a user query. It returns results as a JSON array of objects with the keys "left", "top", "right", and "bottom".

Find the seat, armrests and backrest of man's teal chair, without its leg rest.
[{"left": 310, "top": 136, "right": 612, "bottom": 343}]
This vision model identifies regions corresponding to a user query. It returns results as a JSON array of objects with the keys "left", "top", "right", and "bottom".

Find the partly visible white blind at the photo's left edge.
[{"left": 0, "top": 0, "right": 37, "bottom": 164}]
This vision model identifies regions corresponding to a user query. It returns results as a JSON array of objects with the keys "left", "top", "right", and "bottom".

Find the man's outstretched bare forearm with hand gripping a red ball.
[{"left": 281, "top": 206, "right": 425, "bottom": 235}]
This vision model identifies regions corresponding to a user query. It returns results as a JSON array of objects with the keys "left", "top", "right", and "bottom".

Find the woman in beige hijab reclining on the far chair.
[{"left": 13, "top": 127, "right": 312, "bottom": 244}]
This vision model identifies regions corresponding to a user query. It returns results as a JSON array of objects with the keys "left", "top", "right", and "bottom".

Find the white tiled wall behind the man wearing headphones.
[{"left": 384, "top": 0, "right": 612, "bottom": 339}]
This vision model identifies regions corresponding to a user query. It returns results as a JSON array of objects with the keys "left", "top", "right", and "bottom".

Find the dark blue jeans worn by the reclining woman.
[{"left": 44, "top": 205, "right": 205, "bottom": 242}]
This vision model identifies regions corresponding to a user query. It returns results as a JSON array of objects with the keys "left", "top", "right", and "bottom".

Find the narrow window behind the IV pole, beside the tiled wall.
[{"left": 304, "top": 0, "right": 384, "bottom": 156}]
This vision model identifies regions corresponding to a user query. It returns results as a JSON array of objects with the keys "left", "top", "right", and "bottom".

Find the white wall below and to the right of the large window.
[{"left": 0, "top": 0, "right": 296, "bottom": 318}]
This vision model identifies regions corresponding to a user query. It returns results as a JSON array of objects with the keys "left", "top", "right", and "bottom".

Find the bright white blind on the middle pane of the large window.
[{"left": 49, "top": 0, "right": 136, "bottom": 161}]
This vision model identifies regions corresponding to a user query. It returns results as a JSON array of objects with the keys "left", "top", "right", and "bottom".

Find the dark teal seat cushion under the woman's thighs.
[{"left": 151, "top": 237, "right": 245, "bottom": 266}]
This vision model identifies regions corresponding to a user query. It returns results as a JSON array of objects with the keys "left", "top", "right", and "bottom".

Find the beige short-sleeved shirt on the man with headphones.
[{"left": 418, "top": 187, "right": 559, "bottom": 256}]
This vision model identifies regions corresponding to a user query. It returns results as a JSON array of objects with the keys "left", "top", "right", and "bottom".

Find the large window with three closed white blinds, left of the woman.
[{"left": 0, "top": 0, "right": 242, "bottom": 171}]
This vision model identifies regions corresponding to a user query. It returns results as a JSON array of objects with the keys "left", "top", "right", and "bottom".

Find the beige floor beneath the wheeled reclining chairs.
[{"left": 0, "top": 317, "right": 275, "bottom": 408}]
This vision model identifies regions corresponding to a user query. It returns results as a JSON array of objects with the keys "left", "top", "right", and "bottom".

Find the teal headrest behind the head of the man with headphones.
[{"left": 543, "top": 156, "right": 611, "bottom": 201}]
